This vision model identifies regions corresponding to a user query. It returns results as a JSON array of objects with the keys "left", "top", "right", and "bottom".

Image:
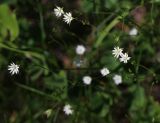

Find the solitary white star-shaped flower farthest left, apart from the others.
[{"left": 8, "top": 63, "right": 19, "bottom": 75}]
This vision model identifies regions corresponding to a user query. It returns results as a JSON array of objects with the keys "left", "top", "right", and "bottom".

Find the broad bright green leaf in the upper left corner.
[{"left": 0, "top": 4, "right": 19, "bottom": 41}]
